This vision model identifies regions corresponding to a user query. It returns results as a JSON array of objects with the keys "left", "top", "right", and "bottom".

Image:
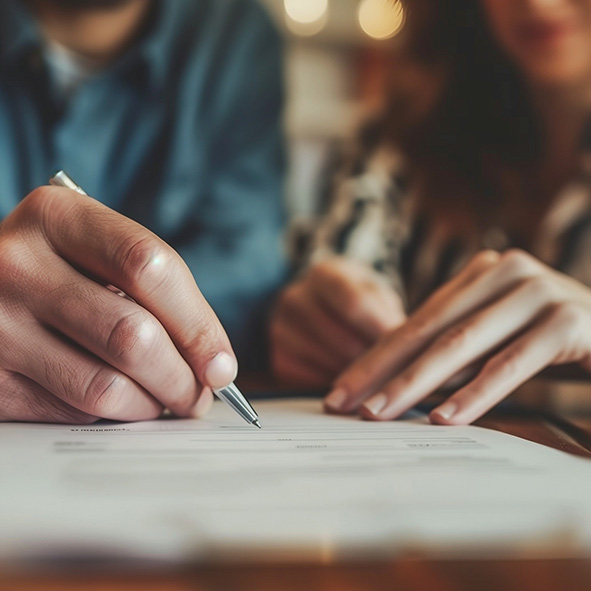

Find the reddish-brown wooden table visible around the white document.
[{"left": 0, "top": 386, "right": 591, "bottom": 591}]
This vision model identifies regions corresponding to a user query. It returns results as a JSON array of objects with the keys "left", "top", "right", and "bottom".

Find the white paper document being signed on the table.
[{"left": 0, "top": 400, "right": 591, "bottom": 562}]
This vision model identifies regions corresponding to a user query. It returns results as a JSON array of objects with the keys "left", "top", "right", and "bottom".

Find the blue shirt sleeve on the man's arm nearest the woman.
[{"left": 179, "top": 3, "right": 287, "bottom": 369}]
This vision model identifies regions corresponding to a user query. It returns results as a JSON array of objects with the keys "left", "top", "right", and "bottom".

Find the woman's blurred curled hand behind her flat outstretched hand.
[{"left": 271, "top": 257, "right": 404, "bottom": 388}]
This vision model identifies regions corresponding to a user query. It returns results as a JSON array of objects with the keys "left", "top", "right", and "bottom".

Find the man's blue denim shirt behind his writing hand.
[{"left": 0, "top": 0, "right": 285, "bottom": 365}]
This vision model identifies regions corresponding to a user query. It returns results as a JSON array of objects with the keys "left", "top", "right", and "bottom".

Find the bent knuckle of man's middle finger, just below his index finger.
[{"left": 107, "top": 311, "right": 158, "bottom": 366}]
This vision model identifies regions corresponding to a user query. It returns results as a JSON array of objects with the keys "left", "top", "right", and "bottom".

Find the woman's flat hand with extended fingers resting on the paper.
[{"left": 325, "top": 250, "right": 591, "bottom": 424}]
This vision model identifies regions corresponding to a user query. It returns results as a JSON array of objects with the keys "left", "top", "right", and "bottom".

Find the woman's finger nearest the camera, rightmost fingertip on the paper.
[{"left": 430, "top": 305, "right": 589, "bottom": 425}]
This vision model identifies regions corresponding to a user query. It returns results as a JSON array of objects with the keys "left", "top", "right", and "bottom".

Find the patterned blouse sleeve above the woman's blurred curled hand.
[{"left": 307, "top": 140, "right": 409, "bottom": 301}]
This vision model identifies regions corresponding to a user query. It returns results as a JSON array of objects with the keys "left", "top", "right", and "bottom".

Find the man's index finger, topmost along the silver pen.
[{"left": 23, "top": 187, "right": 237, "bottom": 389}]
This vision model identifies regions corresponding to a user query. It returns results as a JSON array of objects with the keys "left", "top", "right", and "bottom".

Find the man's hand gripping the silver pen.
[{"left": 0, "top": 187, "right": 237, "bottom": 423}]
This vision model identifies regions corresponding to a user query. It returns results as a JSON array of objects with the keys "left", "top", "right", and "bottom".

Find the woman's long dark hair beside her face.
[{"left": 382, "top": 0, "right": 541, "bottom": 199}]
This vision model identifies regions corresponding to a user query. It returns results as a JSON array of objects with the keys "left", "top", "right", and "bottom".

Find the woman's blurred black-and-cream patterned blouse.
[{"left": 310, "top": 138, "right": 591, "bottom": 311}]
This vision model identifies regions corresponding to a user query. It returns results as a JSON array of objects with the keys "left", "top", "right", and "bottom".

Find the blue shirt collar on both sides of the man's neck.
[{"left": 0, "top": 0, "right": 184, "bottom": 89}]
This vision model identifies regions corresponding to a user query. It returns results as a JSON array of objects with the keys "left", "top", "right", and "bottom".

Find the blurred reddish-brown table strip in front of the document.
[{"left": 0, "top": 558, "right": 591, "bottom": 591}]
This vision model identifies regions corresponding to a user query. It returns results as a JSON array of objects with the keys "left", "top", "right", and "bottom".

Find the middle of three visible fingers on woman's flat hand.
[{"left": 361, "top": 278, "right": 553, "bottom": 420}]
